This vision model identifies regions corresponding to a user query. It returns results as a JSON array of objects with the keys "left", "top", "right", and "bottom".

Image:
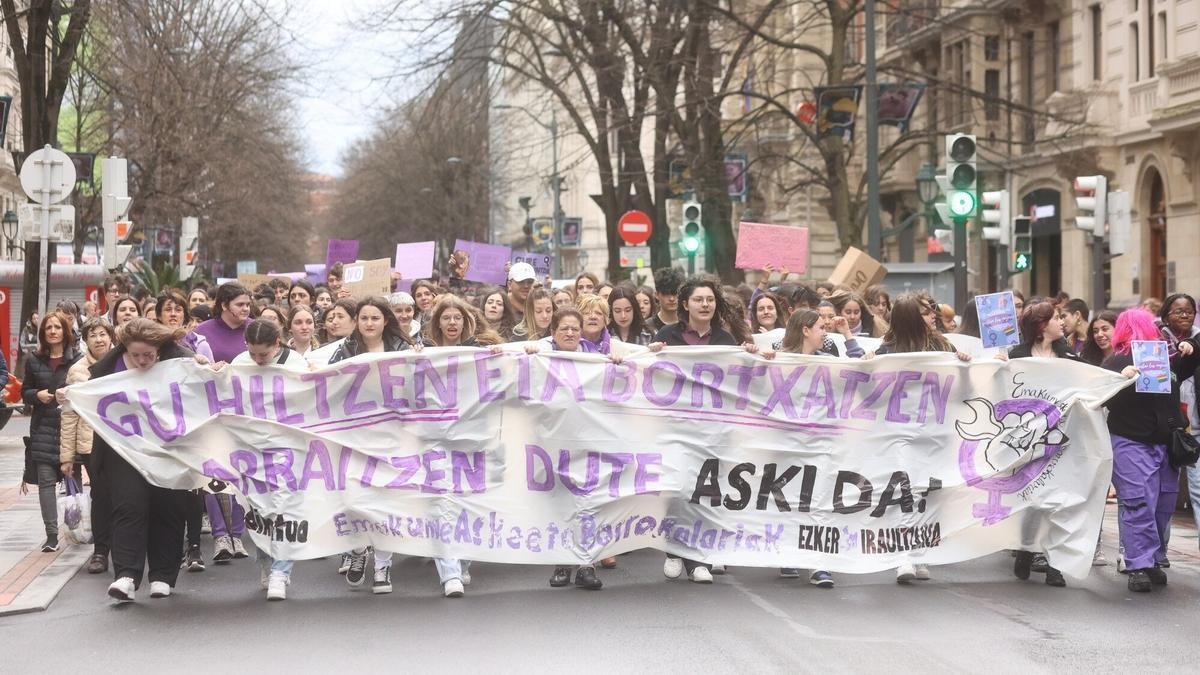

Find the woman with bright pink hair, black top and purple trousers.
[{"left": 1100, "top": 309, "right": 1200, "bottom": 593}]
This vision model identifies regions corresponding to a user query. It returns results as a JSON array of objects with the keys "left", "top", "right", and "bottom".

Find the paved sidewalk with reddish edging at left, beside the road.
[{"left": 0, "top": 416, "right": 91, "bottom": 616}]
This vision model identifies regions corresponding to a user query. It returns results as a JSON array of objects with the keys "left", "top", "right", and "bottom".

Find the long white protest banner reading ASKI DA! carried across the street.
[{"left": 67, "top": 347, "right": 1129, "bottom": 577}]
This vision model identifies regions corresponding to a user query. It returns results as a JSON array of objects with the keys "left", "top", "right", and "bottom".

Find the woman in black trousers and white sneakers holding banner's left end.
[{"left": 90, "top": 314, "right": 198, "bottom": 602}]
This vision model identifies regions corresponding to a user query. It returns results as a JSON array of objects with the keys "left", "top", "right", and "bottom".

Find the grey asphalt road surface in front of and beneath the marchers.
[{"left": 0, "top": 418, "right": 1200, "bottom": 673}]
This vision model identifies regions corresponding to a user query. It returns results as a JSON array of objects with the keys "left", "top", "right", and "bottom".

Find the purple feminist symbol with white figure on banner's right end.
[{"left": 954, "top": 399, "right": 1069, "bottom": 525}]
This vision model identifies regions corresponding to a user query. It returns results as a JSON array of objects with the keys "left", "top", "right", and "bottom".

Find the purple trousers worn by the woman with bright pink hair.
[{"left": 1112, "top": 434, "right": 1180, "bottom": 569}]
